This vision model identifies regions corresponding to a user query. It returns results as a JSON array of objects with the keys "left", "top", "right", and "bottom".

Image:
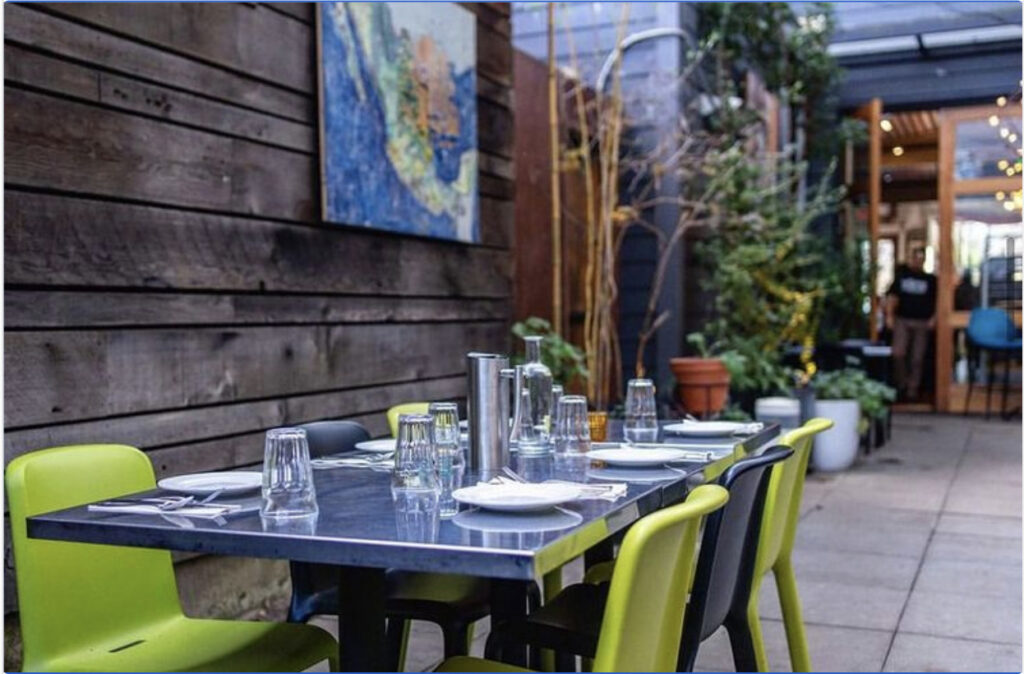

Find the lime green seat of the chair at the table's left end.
[{"left": 37, "top": 616, "right": 338, "bottom": 672}]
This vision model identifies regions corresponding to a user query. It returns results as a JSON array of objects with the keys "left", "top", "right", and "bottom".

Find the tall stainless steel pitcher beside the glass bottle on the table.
[{"left": 466, "top": 352, "right": 515, "bottom": 472}]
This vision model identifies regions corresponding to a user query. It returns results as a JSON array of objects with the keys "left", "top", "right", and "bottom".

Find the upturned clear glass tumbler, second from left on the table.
[{"left": 391, "top": 414, "right": 440, "bottom": 512}]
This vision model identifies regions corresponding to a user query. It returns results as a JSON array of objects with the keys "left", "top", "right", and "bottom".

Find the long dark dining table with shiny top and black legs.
[{"left": 27, "top": 421, "right": 779, "bottom": 671}]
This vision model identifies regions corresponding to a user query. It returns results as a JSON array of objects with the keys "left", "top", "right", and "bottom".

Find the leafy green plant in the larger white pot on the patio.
[{"left": 813, "top": 368, "right": 896, "bottom": 471}]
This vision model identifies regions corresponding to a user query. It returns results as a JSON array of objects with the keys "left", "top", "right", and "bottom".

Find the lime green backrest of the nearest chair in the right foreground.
[{"left": 593, "top": 485, "right": 729, "bottom": 672}]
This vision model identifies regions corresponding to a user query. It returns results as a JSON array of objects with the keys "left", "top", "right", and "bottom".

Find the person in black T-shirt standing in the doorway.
[{"left": 886, "top": 248, "right": 937, "bottom": 401}]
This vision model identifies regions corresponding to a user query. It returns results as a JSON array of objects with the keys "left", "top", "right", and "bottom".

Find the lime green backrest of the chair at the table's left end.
[{"left": 5, "top": 445, "right": 181, "bottom": 671}]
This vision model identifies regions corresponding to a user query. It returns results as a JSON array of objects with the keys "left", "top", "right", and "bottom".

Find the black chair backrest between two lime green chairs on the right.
[{"left": 682, "top": 447, "right": 793, "bottom": 649}]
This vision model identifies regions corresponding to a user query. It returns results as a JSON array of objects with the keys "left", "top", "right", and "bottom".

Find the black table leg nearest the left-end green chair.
[{"left": 338, "top": 566, "right": 391, "bottom": 672}]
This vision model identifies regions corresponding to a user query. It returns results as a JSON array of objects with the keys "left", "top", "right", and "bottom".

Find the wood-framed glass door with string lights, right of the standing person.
[{"left": 935, "top": 104, "right": 1024, "bottom": 412}]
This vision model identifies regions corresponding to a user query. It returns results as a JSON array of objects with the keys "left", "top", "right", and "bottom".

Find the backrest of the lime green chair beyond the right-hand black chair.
[{"left": 755, "top": 418, "right": 833, "bottom": 575}]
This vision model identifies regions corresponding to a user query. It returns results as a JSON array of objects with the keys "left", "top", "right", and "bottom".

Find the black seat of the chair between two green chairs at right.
[{"left": 487, "top": 583, "right": 609, "bottom": 658}]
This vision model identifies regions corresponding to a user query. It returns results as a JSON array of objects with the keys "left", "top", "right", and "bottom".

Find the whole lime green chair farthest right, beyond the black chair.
[{"left": 733, "top": 419, "right": 833, "bottom": 672}]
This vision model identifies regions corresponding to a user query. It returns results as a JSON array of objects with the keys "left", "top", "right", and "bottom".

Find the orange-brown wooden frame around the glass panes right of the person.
[{"left": 935, "top": 103, "right": 1021, "bottom": 412}]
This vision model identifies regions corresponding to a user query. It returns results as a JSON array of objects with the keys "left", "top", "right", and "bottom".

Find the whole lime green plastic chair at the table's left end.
[{"left": 5, "top": 445, "right": 338, "bottom": 672}]
